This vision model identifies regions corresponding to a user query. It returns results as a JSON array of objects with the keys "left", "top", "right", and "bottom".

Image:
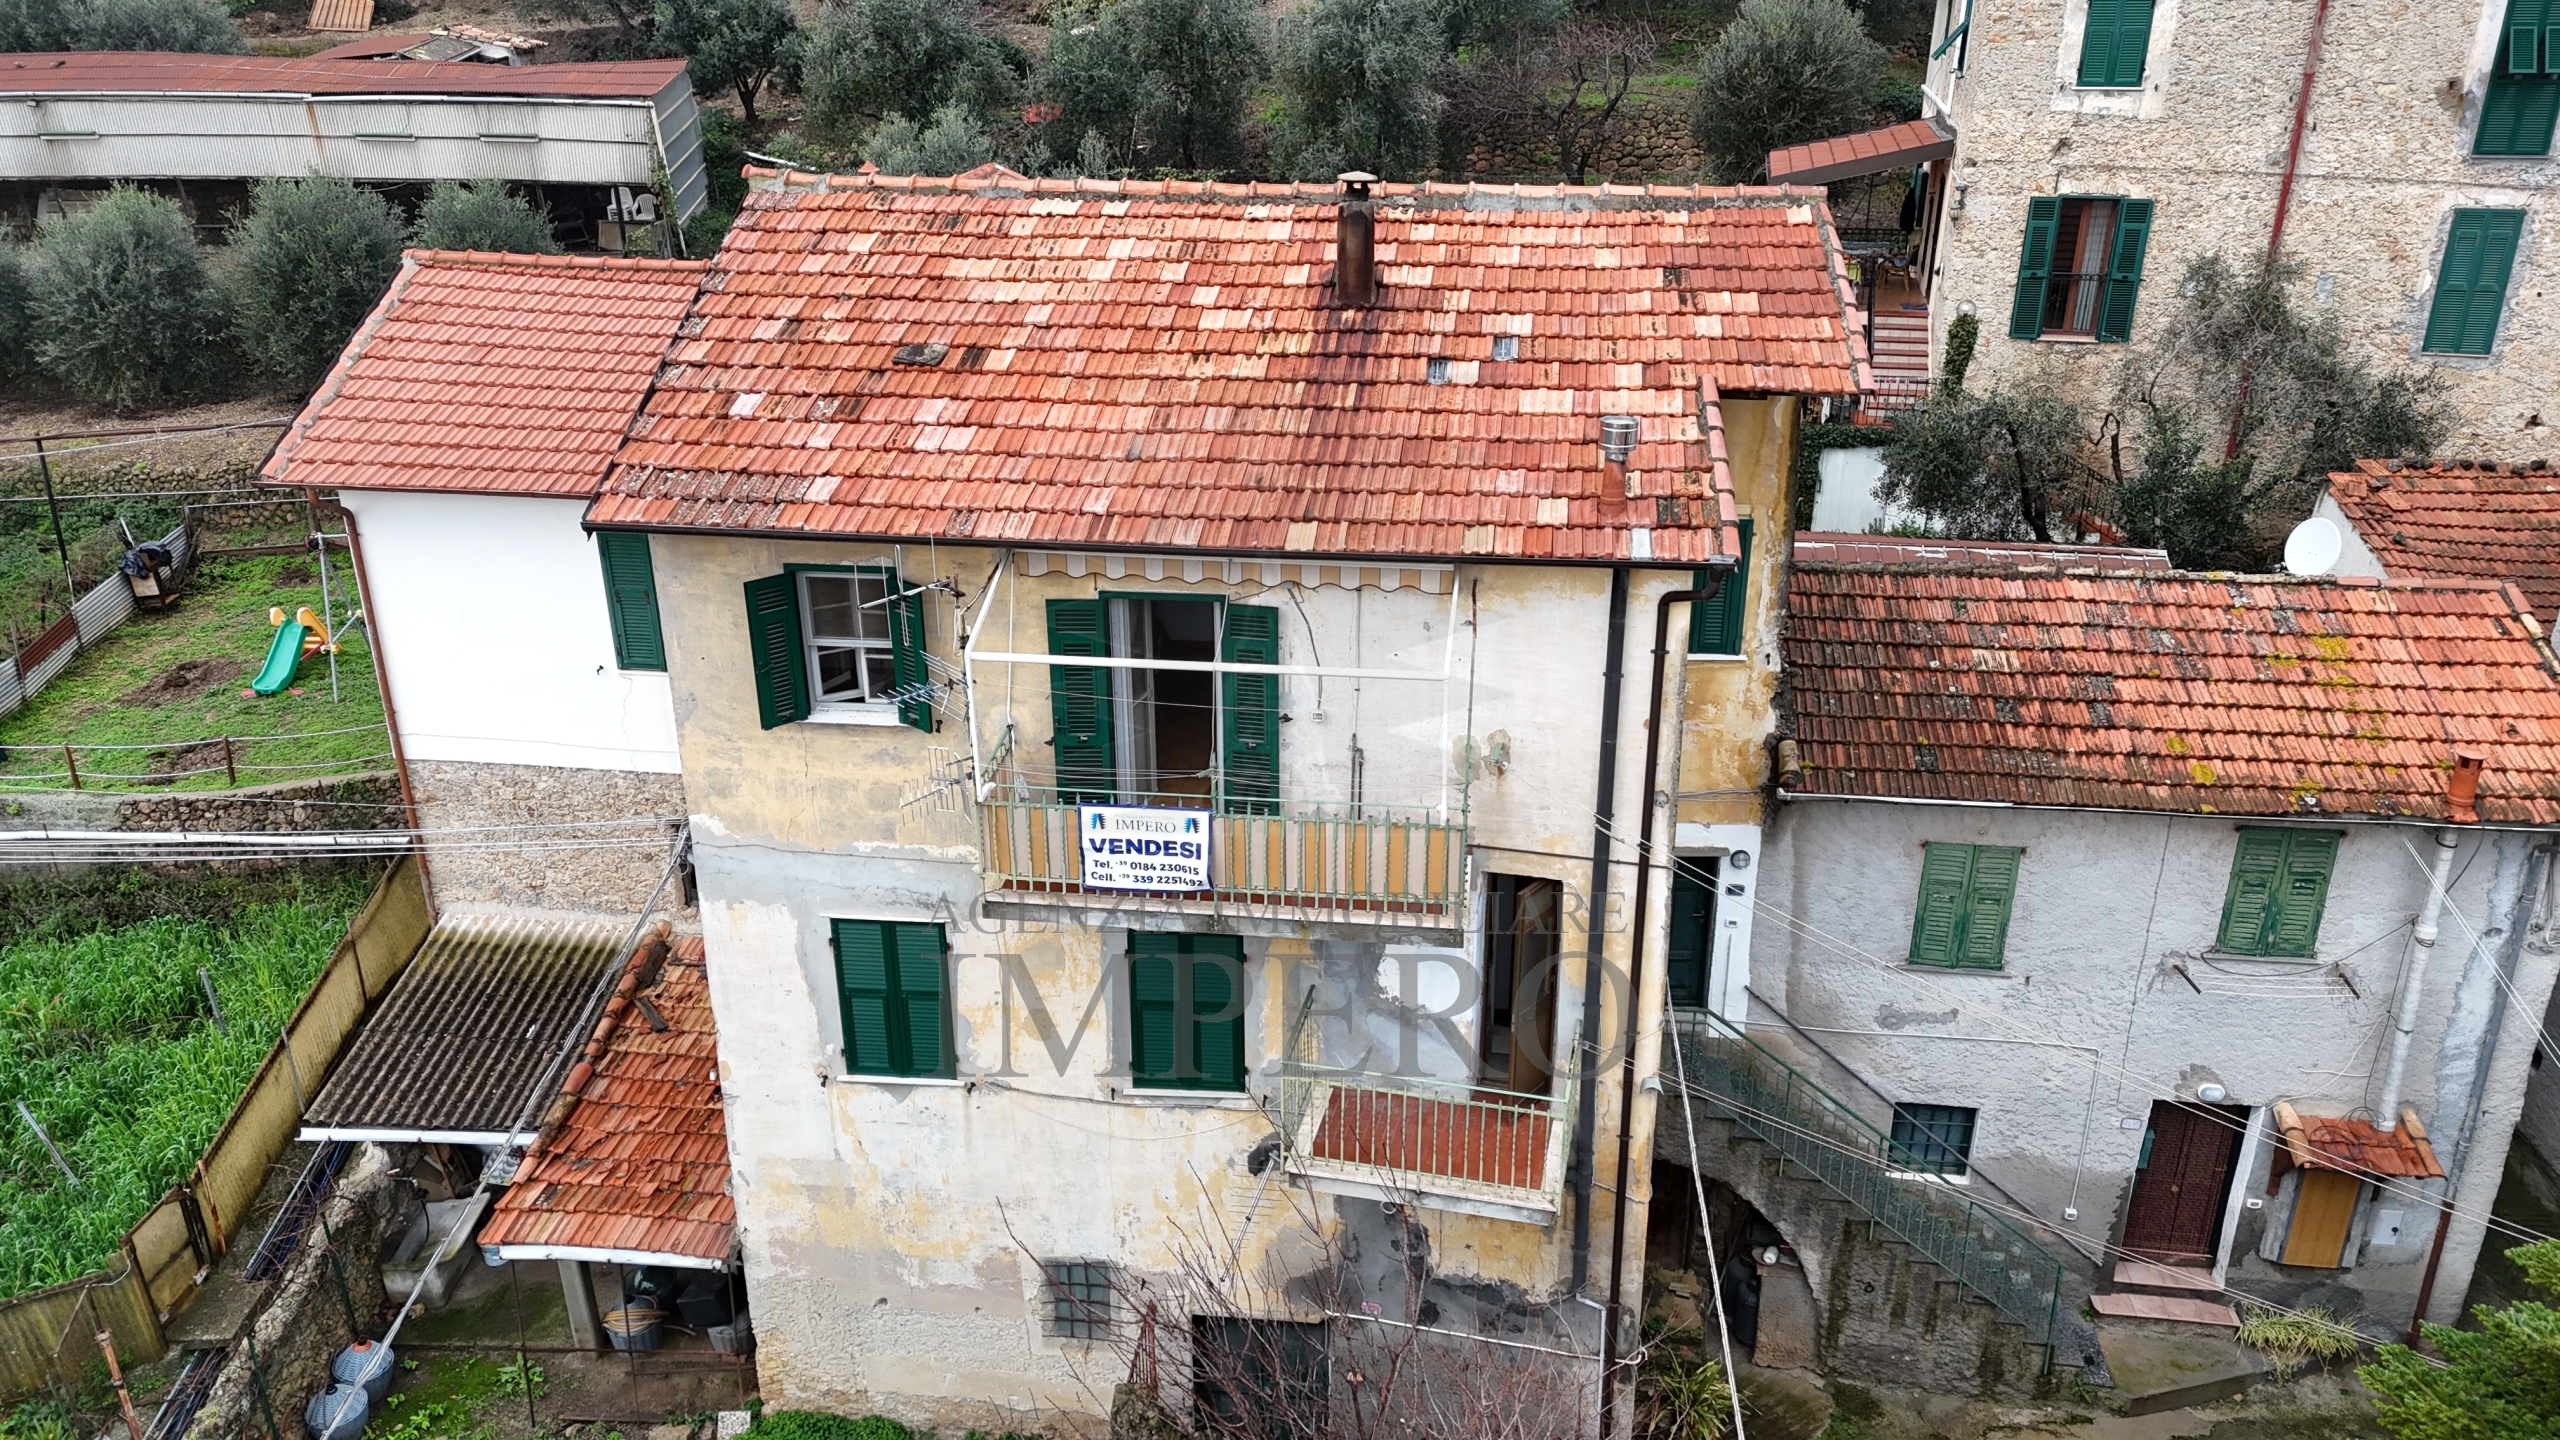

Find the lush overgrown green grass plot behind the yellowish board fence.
[{"left": 0, "top": 871, "right": 371, "bottom": 1294}]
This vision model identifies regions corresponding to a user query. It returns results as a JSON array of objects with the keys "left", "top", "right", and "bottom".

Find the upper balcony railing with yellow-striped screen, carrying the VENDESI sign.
[{"left": 978, "top": 784, "right": 1467, "bottom": 928}]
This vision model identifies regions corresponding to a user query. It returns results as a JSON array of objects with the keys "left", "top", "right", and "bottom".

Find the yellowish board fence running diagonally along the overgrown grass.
[{"left": 0, "top": 858, "right": 435, "bottom": 1402}]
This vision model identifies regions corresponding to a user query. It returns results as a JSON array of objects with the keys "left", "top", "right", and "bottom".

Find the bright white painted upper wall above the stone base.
[{"left": 343, "top": 489, "right": 678, "bottom": 774}]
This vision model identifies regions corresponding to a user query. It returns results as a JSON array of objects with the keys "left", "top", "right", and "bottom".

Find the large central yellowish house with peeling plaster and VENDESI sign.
[{"left": 576, "top": 167, "right": 1861, "bottom": 1435}]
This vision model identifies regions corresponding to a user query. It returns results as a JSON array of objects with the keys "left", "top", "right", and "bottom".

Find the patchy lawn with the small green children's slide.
[{"left": 0, "top": 551, "right": 392, "bottom": 792}]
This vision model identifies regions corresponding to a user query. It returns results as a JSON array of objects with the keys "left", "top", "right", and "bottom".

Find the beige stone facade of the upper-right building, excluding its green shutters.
[{"left": 1930, "top": 0, "right": 2560, "bottom": 461}]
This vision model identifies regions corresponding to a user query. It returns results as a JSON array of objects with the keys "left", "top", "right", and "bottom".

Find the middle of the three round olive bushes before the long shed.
[{"left": 230, "top": 174, "right": 407, "bottom": 387}]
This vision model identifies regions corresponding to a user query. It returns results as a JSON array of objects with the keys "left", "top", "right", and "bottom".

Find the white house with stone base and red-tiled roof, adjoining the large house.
[{"left": 261, "top": 251, "right": 704, "bottom": 915}]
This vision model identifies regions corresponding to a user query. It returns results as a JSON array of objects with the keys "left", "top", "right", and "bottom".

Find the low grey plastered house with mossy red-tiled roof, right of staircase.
[{"left": 1751, "top": 561, "right": 2560, "bottom": 1343}]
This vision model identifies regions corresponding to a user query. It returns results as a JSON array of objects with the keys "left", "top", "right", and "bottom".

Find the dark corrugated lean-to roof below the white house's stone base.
[{"left": 302, "top": 917, "right": 622, "bottom": 1140}]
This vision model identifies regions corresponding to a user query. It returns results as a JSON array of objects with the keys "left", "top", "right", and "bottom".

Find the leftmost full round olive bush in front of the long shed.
[{"left": 23, "top": 184, "right": 220, "bottom": 410}]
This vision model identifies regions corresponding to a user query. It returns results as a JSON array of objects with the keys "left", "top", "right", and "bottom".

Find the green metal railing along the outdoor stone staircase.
[{"left": 1664, "top": 1010, "right": 2063, "bottom": 1345}]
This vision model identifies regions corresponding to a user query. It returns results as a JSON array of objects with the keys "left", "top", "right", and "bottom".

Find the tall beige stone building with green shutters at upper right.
[{"left": 1812, "top": 0, "right": 2560, "bottom": 459}]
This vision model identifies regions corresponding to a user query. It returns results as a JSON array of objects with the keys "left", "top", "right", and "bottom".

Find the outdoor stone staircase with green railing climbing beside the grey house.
[{"left": 1654, "top": 1015, "right": 2107, "bottom": 1396}]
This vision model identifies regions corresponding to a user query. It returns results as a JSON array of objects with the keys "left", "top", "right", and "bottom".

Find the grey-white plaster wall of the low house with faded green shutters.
[{"left": 1751, "top": 799, "right": 2552, "bottom": 1327}]
